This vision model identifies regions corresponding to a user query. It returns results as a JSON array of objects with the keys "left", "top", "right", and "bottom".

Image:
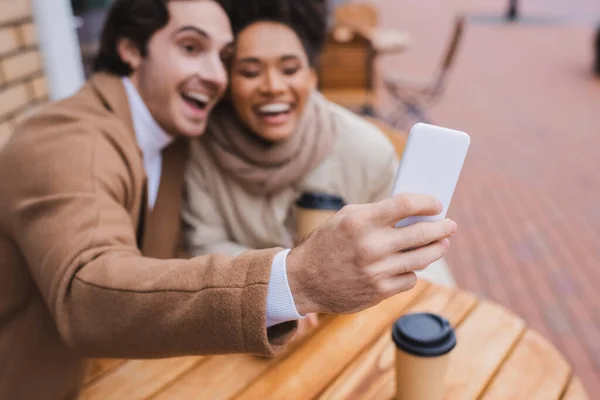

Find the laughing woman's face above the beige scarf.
[{"left": 231, "top": 21, "right": 316, "bottom": 142}]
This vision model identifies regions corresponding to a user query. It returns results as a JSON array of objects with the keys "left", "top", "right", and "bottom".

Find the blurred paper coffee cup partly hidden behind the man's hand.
[{"left": 295, "top": 192, "right": 346, "bottom": 240}]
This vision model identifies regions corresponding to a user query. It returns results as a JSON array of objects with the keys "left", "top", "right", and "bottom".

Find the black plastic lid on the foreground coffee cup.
[{"left": 392, "top": 313, "right": 456, "bottom": 357}]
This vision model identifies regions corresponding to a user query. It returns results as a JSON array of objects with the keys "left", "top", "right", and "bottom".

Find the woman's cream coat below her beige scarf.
[{"left": 183, "top": 103, "right": 398, "bottom": 255}]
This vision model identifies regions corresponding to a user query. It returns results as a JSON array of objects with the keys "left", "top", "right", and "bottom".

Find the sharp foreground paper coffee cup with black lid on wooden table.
[{"left": 392, "top": 313, "right": 456, "bottom": 400}]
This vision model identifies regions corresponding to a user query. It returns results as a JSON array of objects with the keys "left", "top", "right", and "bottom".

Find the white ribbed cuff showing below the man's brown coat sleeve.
[{"left": 267, "top": 249, "right": 304, "bottom": 328}]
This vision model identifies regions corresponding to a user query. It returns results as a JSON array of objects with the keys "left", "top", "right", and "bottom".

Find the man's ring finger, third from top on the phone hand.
[{"left": 365, "top": 239, "right": 450, "bottom": 279}]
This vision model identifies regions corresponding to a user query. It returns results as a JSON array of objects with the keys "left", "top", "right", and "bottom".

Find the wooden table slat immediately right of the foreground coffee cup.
[{"left": 444, "top": 302, "right": 525, "bottom": 400}]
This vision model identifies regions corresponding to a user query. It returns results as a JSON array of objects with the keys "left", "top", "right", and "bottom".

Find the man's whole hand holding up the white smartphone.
[{"left": 286, "top": 194, "right": 457, "bottom": 314}]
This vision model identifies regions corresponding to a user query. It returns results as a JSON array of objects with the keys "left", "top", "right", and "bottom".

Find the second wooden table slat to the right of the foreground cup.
[{"left": 483, "top": 330, "right": 571, "bottom": 400}]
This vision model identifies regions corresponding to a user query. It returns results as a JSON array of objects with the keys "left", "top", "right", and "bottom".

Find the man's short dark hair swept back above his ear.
[{"left": 93, "top": 0, "right": 232, "bottom": 76}]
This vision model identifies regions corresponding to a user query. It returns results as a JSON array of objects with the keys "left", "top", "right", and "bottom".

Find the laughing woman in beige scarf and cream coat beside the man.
[{"left": 183, "top": 7, "right": 397, "bottom": 334}]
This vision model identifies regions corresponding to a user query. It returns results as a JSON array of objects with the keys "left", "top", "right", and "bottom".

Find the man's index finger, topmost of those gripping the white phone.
[{"left": 361, "top": 193, "right": 443, "bottom": 227}]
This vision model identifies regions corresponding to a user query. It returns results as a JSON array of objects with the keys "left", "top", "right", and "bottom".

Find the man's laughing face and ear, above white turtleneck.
[{"left": 119, "top": 0, "right": 233, "bottom": 136}]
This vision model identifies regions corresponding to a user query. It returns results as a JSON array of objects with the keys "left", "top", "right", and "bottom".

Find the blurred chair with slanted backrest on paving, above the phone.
[{"left": 383, "top": 15, "right": 465, "bottom": 128}]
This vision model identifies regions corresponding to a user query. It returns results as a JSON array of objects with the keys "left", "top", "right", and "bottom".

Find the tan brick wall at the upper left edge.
[{"left": 0, "top": 0, "right": 48, "bottom": 148}]
